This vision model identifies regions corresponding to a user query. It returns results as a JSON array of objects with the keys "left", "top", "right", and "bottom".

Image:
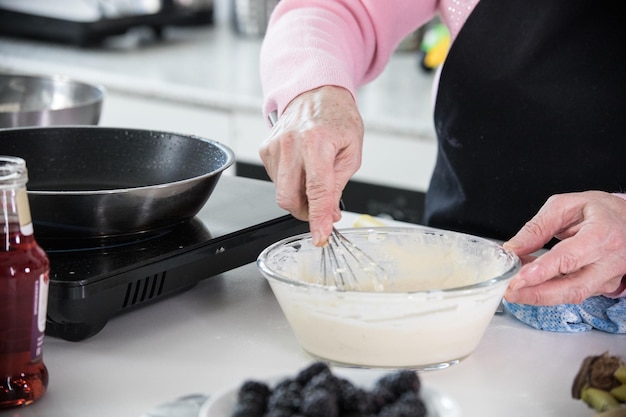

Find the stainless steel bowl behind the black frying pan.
[{"left": 0, "top": 74, "right": 105, "bottom": 128}]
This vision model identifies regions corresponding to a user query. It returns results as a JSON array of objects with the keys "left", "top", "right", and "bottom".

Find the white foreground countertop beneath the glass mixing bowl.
[{"left": 0, "top": 214, "right": 626, "bottom": 417}]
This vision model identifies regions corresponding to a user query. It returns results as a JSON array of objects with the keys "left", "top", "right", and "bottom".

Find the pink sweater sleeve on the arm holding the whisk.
[{"left": 260, "top": 0, "right": 438, "bottom": 117}]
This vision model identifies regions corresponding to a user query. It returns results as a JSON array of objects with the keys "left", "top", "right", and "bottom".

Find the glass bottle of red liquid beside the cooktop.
[{"left": 0, "top": 157, "right": 49, "bottom": 409}]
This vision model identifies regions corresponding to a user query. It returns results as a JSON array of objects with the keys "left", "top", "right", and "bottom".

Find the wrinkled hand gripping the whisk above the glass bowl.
[{"left": 259, "top": 86, "right": 363, "bottom": 246}]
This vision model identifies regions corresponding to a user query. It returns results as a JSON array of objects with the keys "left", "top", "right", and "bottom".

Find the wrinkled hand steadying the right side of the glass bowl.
[{"left": 504, "top": 191, "right": 626, "bottom": 305}]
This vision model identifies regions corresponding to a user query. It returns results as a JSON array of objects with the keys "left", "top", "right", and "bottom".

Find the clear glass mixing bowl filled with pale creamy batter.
[{"left": 257, "top": 226, "right": 521, "bottom": 370}]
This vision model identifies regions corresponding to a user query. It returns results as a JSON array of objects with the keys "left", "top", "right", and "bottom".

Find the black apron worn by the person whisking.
[{"left": 424, "top": 0, "right": 626, "bottom": 239}]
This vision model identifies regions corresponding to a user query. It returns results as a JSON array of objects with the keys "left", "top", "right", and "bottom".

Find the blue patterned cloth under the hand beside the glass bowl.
[{"left": 503, "top": 295, "right": 626, "bottom": 333}]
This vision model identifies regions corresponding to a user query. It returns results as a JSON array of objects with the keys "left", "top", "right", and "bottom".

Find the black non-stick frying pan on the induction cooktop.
[{"left": 0, "top": 126, "right": 235, "bottom": 238}]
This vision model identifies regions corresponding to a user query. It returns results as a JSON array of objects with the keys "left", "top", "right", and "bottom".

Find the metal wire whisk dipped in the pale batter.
[{"left": 320, "top": 227, "right": 389, "bottom": 291}]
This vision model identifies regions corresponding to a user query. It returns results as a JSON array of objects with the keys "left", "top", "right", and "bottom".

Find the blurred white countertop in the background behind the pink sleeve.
[{"left": 0, "top": 24, "right": 434, "bottom": 139}]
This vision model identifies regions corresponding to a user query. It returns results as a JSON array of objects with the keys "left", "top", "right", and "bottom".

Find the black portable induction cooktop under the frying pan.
[{"left": 41, "top": 175, "right": 308, "bottom": 341}]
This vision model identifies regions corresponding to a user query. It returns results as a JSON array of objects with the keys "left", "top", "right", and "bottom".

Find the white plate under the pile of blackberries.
[{"left": 198, "top": 369, "right": 461, "bottom": 417}]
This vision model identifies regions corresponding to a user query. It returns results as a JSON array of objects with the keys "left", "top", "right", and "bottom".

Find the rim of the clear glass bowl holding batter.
[{"left": 256, "top": 225, "right": 522, "bottom": 295}]
